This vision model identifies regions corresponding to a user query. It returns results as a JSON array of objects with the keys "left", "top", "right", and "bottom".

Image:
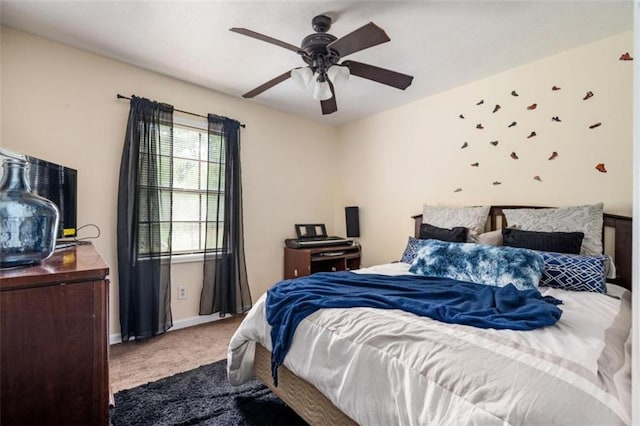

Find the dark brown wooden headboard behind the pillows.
[{"left": 412, "top": 206, "right": 632, "bottom": 291}]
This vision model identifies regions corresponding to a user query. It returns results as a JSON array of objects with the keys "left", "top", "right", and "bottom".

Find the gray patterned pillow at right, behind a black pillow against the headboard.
[{"left": 503, "top": 203, "right": 604, "bottom": 256}]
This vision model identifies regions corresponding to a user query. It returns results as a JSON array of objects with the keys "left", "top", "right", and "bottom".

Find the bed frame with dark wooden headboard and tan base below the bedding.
[{"left": 254, "top": 206, "right": 632, "bottom": 426}]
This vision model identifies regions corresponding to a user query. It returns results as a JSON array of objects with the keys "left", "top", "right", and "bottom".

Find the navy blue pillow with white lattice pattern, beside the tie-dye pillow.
[{"left": 540, "top": 252, "right": 607, "bottom": 293}]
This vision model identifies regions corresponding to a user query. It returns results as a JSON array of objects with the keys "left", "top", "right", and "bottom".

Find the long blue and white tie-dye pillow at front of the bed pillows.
[{"left": 409, "top": 240, "right": 544, "bottom": 290}]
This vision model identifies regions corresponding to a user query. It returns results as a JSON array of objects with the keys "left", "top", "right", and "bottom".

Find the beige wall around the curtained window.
[{"left": 0, "top": 28, "right": 337, "bottom": 334}]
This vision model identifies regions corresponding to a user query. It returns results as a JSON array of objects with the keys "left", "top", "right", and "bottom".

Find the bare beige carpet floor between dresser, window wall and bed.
[{"left": 109, "top": 316, "right": 244, "bottom": 393}]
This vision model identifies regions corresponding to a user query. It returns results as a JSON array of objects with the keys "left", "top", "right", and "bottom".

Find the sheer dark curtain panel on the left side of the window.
[{"left": 117, "top": 96, "right": 173, "bottom": 341}]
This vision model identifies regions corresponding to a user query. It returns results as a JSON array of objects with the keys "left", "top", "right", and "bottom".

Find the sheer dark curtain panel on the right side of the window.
[{"left": 200, "top": 114, "right": 251, "bottom": 316}]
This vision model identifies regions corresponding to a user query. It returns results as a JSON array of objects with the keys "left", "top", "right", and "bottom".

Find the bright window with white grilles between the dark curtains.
[{"left": 139, "top": 117, "right": 225, "bottom": 256}]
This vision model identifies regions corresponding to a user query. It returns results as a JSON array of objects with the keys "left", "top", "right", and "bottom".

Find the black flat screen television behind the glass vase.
[{"left": 0, "top": 148, "right": 78, "bottom": 239}]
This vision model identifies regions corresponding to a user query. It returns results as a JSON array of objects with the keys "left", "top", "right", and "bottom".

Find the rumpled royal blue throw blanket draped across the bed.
[{"left": 266, "top": 272, "right": 562, "bottom": 386}]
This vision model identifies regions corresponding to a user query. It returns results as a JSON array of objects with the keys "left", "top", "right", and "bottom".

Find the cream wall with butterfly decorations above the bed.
[{"left": 335, "top": 32, "right": 633, "bottom": 265}]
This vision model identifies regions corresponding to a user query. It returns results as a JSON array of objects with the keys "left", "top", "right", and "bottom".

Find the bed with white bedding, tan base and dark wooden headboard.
[{"left": 228, "top": 206, "right": 631, "bottom": 425}]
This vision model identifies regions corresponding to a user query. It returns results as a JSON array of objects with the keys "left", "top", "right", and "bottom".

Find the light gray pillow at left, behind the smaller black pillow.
[{"left": 422, "top": 204, "right": 491, "bottom": 234}]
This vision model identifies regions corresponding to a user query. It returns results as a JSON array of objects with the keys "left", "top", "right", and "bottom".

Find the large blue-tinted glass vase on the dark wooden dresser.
[{"left": 0, "top": 158, "right": 59, "bottom": 268}]
